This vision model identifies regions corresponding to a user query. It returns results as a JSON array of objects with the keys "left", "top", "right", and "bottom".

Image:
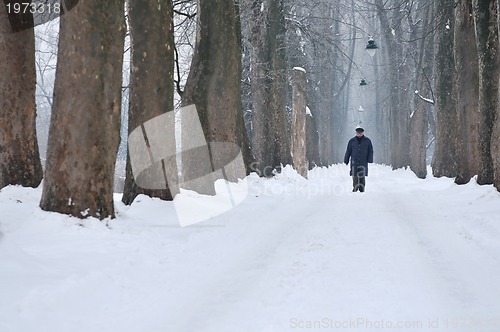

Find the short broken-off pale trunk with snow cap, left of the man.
[{"left": 292, "top": 68, "right": 309, "bottom": 179}]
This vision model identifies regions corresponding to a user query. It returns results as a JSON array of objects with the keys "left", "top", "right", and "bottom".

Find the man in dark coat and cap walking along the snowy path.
[{"left": 344, "top": 126, "right": 373, "bottom": 192}]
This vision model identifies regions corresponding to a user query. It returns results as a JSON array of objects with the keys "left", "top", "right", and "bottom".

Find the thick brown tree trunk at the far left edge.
[{"left": 0, "top": 1, "right": 42, "bottom": 189}]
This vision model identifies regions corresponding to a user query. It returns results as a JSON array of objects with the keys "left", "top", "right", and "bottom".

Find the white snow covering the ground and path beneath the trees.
[{"left": 0, "top": 165, "right": 500, "bottom": 332}]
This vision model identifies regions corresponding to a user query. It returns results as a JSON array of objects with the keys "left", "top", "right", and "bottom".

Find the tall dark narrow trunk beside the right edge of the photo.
[{"left": 473, "top": 0, "right": 500, "bottom": 184}]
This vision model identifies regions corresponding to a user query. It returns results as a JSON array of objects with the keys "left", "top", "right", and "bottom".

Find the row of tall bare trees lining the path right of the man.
[{"left": 375, "top": 0, "right": 500, "bottom": 188}]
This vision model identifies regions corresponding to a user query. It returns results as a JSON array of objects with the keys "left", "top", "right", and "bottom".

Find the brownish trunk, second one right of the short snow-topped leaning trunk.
[{"left": 454, "top": 0, "right": 479, "bottom": 184}]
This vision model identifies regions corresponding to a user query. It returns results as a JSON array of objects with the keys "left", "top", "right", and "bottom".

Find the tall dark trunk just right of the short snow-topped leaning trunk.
[{"left": 432, "top": 0, "right": 458, "bottom": 177}]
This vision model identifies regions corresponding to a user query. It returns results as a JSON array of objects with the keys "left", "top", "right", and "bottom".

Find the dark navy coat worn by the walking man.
[{"left": 344, "top": 136, "right": 373, "bottom": 176}]
